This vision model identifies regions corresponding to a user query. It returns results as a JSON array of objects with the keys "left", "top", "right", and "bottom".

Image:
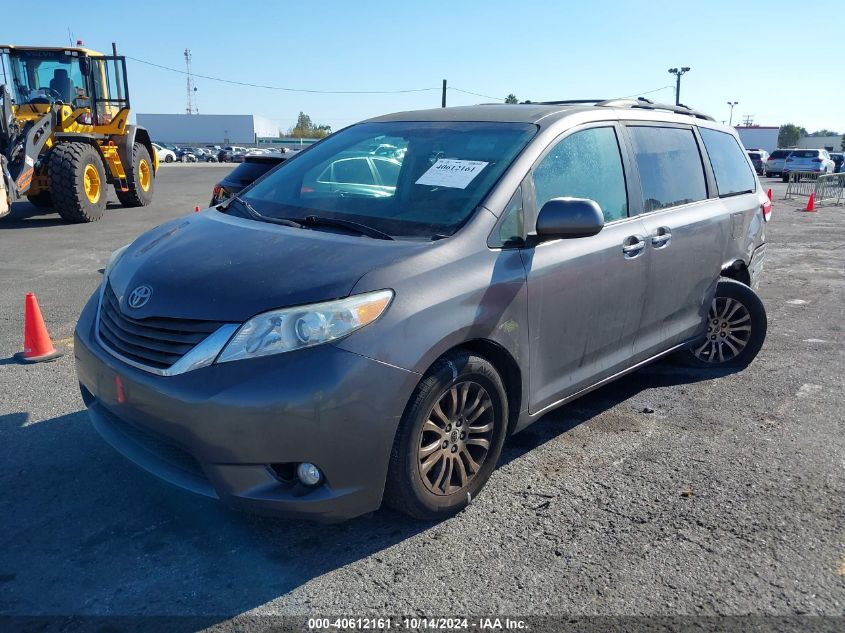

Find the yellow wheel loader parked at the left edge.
[{"left": 0, "top": 45, "right": 158, "bottom": 222}]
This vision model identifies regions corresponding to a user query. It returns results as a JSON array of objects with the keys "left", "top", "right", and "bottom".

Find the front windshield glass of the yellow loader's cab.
[{"left": 9, "top": 51, "right": 85, "bottom": 105}]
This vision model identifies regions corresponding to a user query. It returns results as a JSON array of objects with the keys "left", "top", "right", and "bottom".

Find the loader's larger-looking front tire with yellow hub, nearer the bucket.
[{"left": 48, "top": 143, "right": 108, "bottom": 223}]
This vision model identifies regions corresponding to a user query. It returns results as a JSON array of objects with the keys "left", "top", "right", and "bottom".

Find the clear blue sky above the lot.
[{"left": 9, "top": 0, "right": 845, "bottom": 133}]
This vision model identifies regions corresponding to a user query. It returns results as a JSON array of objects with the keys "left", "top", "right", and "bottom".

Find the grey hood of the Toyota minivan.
[{"left": 109, "top": 211, "right": 431, "bottom": 323}]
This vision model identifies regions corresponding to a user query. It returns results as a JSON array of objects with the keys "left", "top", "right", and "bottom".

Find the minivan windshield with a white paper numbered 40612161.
[{"left": 243, "top": 121, "right": 537, "bottom": 239}]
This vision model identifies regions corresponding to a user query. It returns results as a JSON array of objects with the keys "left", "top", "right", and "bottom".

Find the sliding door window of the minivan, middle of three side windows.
[{"left": 628, "top": 126, "right": 707, "bottom": 211}]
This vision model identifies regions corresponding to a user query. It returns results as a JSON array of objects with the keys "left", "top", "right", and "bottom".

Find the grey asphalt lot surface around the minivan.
[{"left": 0, "top": 165, "right": 845, "bottom": 620}]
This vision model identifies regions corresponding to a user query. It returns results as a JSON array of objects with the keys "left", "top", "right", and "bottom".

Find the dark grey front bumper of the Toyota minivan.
[{"left": 74, "top": 295, "right": 419, "bottom": 521}]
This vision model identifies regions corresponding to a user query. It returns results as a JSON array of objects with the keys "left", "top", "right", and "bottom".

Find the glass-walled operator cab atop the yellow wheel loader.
[{"left": 0, "top": 46, "right": 129, "bottom": 131}]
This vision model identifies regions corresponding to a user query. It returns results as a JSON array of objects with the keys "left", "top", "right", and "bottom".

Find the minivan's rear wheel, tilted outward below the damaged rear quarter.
[{"left": 680, "top": 279, "right": 768, "bottom": 368}]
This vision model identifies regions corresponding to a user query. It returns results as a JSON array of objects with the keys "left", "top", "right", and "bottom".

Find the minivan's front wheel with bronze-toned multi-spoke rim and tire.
[{"left": 384, "top": 352, "right": 508, "bottom": 520}]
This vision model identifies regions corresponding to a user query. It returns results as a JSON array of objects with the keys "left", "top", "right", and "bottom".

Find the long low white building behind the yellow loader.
[{"left": 137, "top": 114, "right": 279, "bottom": 145}]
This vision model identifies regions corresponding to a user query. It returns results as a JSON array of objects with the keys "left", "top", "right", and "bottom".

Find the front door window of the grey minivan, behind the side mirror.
[{"left": 533, "top": 127, "right": 628, "bottom": 222}]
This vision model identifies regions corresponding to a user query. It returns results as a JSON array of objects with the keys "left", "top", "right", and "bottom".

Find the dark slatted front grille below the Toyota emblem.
[{"left": 99, "top": 283, "right": 223, "bottom": 369}]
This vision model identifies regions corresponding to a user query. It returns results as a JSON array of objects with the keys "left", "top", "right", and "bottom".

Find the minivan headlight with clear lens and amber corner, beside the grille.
[{"left": 217, "top": 290, "right": 393, "bottom": 363}]
